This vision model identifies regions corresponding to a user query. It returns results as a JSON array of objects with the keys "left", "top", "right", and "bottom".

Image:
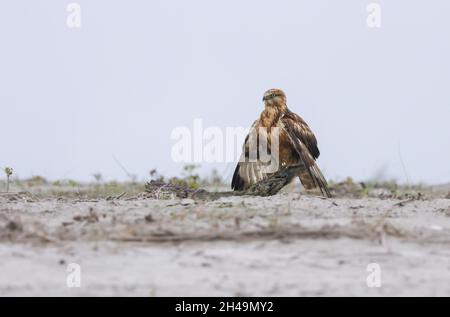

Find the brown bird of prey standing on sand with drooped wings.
[{"left": 231, "top": 89, "right": 331, "bottom": 197}]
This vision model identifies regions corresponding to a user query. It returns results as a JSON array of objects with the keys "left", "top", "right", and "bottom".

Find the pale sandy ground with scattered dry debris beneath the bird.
[{"left": 0, "top": 184, "right": 450, "bottom": 296}]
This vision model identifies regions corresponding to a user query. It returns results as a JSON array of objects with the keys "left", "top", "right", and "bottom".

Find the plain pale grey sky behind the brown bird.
[{"left": 0, "top": 0, "right": 450, "bottom": 183}]
